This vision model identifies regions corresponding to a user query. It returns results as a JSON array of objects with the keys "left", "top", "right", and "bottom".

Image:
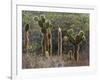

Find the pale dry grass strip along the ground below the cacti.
[{"left": 22, "top": 54, "right": 89, "bottom": 69}]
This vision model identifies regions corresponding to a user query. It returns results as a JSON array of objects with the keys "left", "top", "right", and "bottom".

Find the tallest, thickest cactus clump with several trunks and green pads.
[{"left": 34, "top": 15, "right": 52, "bottom": 54}]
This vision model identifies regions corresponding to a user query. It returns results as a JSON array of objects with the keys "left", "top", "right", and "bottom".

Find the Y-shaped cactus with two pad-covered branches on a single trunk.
[{"left": 67, "top": 29, "right": 85, "bottom": 61}]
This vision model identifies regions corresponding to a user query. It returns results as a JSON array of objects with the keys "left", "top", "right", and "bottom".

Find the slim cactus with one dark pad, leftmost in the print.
[{"left": 24, "top": 24, "right": 29, "bottom": 53}]
